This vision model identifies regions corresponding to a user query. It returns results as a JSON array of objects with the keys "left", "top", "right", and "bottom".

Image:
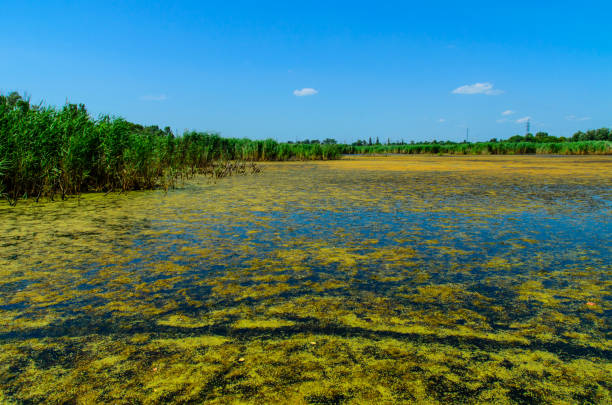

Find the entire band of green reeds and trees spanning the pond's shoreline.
[{"left": 0, "top": 92, "right": 612, "bottom": 205}]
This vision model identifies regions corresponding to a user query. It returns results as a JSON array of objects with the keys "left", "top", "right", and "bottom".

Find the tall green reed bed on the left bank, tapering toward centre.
[{"left": 0, "top": 93, "right": 339, "bottom": 204}]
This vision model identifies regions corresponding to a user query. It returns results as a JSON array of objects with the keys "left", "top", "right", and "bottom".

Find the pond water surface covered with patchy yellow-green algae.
[{"left": 0, "top": 156, "right": 612, "bottom": 404}]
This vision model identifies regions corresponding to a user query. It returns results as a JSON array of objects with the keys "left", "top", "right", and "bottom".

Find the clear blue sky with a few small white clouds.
[{"left": 0, "top": 0, "right": 612, "bottom": 142}]
